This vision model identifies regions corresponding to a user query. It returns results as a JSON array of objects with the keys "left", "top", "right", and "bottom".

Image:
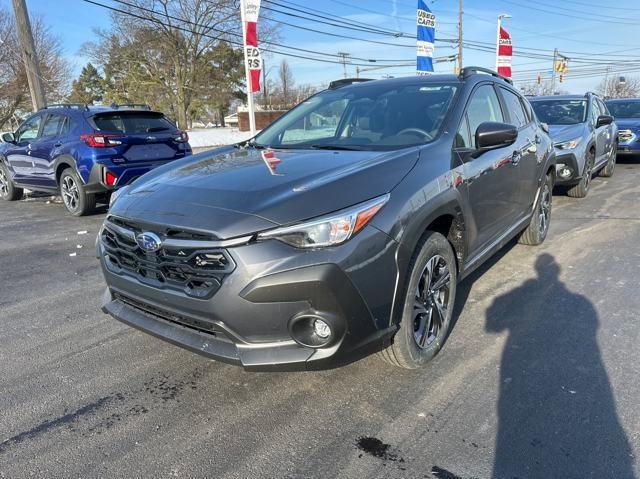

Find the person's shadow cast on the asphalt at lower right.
[{"left": 486, "top": 254, "right": 635, "bottom": 479}]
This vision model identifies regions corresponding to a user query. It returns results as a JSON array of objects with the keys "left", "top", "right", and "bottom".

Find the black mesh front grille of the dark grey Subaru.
[{"left": 100, "top": 216, "right": 235, "bottom": 298}]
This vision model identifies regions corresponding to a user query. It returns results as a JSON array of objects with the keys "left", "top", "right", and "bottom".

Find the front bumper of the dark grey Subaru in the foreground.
[{"left": 98, "top": 226, "right": 397, "bottom": 370}]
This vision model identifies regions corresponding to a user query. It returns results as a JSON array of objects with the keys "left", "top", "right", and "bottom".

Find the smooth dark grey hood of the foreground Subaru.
[{"left": 110, "top": 147, "right": 418, "bottom": 239}]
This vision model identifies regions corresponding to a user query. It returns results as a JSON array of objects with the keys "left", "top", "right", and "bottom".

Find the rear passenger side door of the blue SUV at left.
[{"left": 31, "top": 113, "right": 69, "bottom": 188}]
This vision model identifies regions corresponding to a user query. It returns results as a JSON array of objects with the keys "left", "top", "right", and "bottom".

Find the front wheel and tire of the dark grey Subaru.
[{"left": 380, "top": 231, "right": 458, "bottom": 369}]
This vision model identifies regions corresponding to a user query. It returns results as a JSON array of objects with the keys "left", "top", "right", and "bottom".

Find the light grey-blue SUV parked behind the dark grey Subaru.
[{"left": 529, "top": 93, "right": 618, "bottom": 198}]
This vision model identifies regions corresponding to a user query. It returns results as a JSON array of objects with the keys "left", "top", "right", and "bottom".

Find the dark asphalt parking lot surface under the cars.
[{"left": 0, "top": 161, "right": 640, "bottom": 479}]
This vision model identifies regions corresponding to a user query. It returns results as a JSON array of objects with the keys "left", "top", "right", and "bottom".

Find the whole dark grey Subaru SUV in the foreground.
[{"left": 97, "top": 68, "right": 555, "bottom": 369}]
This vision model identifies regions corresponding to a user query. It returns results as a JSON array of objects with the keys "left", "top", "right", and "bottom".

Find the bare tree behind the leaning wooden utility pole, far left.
[{"left": 0, "top": 8, "right": 70, "bottom": 128}]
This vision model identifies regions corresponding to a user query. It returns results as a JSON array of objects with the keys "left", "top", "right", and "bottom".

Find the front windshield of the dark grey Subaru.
[{"left": 254, "top": 81, "right": 456, "bottom": 150}]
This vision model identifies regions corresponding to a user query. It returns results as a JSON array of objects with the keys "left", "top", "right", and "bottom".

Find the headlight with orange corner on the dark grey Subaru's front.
[{"left": 258, "top": 194, "right": 389, "bottom": 248}]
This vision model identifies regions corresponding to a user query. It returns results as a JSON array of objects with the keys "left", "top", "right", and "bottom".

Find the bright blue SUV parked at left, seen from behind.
[{"left": 0, "top": 104, "right": 191, "bottom": 216}]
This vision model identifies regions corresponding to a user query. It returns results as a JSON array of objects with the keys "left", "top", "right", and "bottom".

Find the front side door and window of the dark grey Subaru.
[{"left": 455, "top": 83, "right": 519, "bottom": 257}]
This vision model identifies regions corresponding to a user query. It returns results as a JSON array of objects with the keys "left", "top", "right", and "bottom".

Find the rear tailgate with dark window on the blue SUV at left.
[{"left": 91, "top": 111, "right": 185, "bottom": 163}]
